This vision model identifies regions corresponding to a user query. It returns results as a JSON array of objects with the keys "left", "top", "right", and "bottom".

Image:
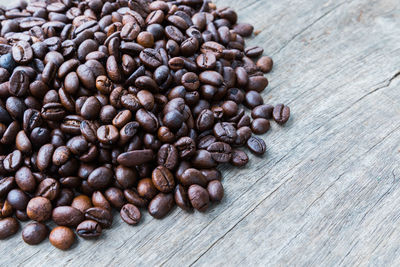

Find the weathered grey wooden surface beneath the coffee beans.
[{"left": 0, "top": 0, "right": 400, "bottom": 266}]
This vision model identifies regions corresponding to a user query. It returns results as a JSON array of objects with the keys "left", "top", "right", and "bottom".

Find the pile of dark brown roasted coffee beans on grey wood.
[{"left": 0, "top": 0, "right": 290, "bottom": 249}]
